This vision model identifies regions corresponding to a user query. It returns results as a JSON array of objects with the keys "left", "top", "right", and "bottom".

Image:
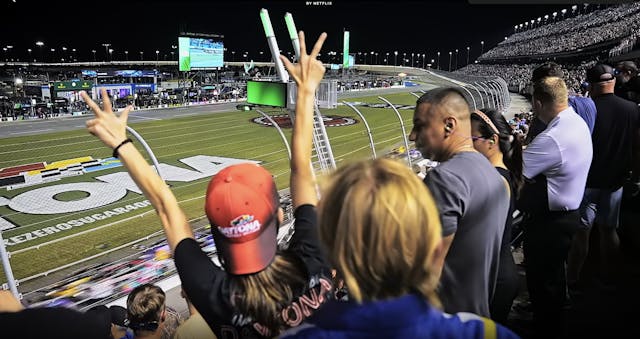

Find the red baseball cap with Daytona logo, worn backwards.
[{"left": 205, "top": 163, "right": 279, "bottom": 275}]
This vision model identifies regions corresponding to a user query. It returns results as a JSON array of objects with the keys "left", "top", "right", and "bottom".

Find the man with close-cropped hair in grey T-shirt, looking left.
[{"left": 409, "top": 87, "right": 509, "bottom": 318}]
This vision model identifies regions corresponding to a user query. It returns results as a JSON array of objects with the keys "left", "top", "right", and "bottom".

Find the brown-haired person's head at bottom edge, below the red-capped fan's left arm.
[{"left": 127, "top": 284, "right": 167, "bottom": 339}]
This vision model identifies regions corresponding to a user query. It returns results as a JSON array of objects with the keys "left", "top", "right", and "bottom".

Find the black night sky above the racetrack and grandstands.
[{"left": 0, "top": 0, "right": 571, "bottom": 64}]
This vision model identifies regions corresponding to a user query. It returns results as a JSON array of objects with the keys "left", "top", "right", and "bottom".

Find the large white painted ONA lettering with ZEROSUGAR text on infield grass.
[{"left": 0, "top": 155, "right": 259, "bottom": 246}]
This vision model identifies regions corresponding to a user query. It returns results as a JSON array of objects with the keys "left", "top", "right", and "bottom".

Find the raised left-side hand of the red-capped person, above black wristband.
[{"left": 80, "top": 88, "right": 133, "bottom": 148}]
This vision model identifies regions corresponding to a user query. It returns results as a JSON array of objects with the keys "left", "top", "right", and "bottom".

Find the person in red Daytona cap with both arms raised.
[{"left": 82, "top": 33, "right": 333, "bottom": 338}]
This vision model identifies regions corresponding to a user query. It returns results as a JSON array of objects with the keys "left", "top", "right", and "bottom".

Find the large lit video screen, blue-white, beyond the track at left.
[{"left": 178, "top": 37, "right": 224, "bottom": 71}]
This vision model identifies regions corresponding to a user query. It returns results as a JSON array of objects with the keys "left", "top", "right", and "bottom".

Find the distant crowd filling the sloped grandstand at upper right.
[{"left": 479, "top": 2, "right": 640, "bottom": 60}]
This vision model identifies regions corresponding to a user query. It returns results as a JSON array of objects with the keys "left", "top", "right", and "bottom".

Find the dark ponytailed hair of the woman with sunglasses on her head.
[{"left": 471, "top": 108, "right": 524, "bottom": 196}]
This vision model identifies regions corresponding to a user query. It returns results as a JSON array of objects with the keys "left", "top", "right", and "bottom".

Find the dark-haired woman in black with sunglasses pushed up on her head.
[{"left": 471, "top": 109, "right": 524, "bottom": 324}]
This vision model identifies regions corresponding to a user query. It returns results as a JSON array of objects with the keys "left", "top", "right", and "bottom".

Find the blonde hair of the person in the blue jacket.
[{"left": 318, "top": 159, "right": 441, "bottom": 307}]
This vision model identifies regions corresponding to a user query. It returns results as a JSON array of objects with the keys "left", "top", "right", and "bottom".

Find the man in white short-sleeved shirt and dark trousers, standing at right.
[{"left": 517, "top": 77, "right": 592, "bottom": 338}]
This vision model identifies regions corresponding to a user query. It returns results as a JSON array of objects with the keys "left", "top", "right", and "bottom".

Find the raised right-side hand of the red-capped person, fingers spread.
[{"left": 280, "top": 31, "right": 327, "bottom": 93}]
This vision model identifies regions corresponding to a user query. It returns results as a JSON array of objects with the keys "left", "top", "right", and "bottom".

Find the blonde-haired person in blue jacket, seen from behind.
[{"left": 282, "top": 158, "right": 517, "bottom": 338}]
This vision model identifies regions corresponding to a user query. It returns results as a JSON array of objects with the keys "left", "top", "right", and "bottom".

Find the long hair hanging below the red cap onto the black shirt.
[{"left": 231, "top": 251, "right": 309, "bottom": 335}]
